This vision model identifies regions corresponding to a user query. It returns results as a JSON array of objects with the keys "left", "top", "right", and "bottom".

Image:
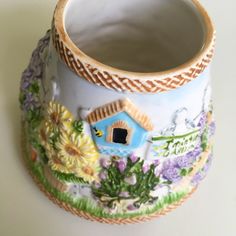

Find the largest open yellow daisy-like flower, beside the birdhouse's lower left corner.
[{"left": 56, "top": 132, "right": 99, "bottom": 168}]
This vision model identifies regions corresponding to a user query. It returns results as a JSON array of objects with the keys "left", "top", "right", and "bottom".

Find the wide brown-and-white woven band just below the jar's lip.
[{"left": 52, "top": 19, "right": 215, "bottom": 93}]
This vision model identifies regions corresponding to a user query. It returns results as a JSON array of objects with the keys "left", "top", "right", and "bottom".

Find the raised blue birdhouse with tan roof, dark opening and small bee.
[{"left": 87, "top": 99, "right": 153, "bottom": 157}]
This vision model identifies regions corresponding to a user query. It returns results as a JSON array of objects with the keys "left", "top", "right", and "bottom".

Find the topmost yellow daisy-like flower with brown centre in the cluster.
[{"left": 45, "top": 102, "right": 73, "bottom": 132}]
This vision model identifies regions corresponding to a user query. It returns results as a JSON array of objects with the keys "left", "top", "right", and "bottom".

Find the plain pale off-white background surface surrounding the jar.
[{"left": 0, "top": 0, "right": 236, "bottom": 236}]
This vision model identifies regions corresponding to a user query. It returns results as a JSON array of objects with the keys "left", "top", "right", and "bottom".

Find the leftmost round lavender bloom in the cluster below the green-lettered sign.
[{"left": 161, "top": 162, "right": 181, "bottom": 183}]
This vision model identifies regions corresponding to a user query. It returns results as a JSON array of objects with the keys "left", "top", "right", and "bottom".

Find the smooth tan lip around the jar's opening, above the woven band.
[{"left": 53, "top": 0, "right": 215, "bottom": 80}]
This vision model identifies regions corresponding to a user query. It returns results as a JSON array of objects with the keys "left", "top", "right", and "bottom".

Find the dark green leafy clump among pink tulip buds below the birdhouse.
[{"left": 92, "top": 158, "right": 160, "bottom": 208}]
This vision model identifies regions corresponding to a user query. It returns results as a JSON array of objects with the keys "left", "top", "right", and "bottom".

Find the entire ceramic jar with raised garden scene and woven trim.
[{"left": 20, "top": 0, "right": 215, "bottom": 223}]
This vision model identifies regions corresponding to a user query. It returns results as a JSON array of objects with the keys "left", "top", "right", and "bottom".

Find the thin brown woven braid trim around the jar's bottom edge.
[{"left": 21, "top": 125, "right": 196, "bottom": 225}]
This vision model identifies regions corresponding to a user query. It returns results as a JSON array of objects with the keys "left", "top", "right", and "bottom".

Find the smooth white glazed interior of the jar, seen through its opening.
[{"left": 64, "top": 0, "right": 205, "bottom": 72}]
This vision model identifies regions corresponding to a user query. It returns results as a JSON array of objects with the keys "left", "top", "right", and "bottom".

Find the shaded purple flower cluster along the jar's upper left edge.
[{"left": 20, "top": 32, "right": 50, "bottom": 112}]
